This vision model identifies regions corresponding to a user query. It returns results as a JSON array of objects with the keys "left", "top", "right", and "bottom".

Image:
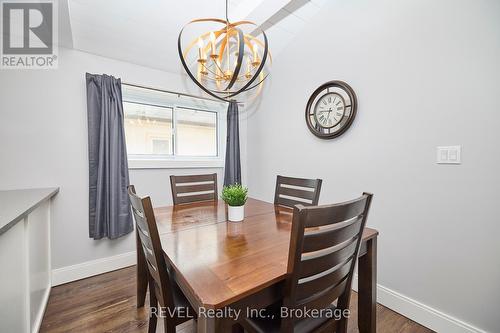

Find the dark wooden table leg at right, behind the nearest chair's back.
[{"left": 358, "top": 237, "right": 377, "bottom": 333}]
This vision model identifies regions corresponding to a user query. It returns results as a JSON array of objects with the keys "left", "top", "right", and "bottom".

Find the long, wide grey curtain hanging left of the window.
[{"left": 86, "top": 73, "right": 134, "bottom": 239}]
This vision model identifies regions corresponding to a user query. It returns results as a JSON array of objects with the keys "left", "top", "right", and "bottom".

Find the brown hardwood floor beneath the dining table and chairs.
[{"left": 40, "top": 266, "right": 432, "bottom": 333}]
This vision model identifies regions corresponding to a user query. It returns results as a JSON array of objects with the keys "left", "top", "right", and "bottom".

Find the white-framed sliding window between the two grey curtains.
[{"left": 122, "top": 84, "right": 227, "bottom": 168}]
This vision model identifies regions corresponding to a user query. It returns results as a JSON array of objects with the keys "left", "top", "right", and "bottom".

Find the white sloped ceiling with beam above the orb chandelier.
[{"left": 59, "top": 0, "right": 327, "bottom": 73}]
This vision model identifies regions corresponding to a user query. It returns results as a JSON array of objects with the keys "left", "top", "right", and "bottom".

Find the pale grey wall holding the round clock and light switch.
[{"left": 248, "top": 0, "right": 500, "bottom": 332}]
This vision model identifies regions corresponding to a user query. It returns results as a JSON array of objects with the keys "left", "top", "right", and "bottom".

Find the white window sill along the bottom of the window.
[{"left": 128, "top": 158, "right": 224, "bottom": 169}]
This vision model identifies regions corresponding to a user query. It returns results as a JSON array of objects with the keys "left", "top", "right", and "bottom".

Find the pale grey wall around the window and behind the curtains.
[{"left": 0, "top": 49, "right": 246, "bottom": 269}]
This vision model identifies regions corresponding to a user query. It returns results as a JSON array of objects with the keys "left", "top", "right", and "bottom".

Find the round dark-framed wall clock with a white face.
[{"left": 306, "top": 81, "right": 357, "bottom": 139}]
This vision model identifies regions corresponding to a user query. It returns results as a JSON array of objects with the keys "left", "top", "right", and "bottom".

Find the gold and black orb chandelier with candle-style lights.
[{"left": 177, "top": 0, "right": 272, "bottom": 101}]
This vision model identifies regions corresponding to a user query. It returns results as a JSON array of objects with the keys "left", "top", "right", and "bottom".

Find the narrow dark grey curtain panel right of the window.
[{"left": 224, "top": 101, "right": 241, "bottom": 185}]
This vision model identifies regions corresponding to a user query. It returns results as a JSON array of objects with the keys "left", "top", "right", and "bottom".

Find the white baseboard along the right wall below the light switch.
[{"left": 352, "top": 275, "right": 487, "bottom": 333}]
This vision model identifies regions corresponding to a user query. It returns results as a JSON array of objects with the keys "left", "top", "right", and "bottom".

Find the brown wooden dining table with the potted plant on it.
[{"left": 137, "top": 198, "right": 378, "bottom": 333}]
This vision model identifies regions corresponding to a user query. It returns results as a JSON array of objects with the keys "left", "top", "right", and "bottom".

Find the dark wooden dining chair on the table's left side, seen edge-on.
[{"left": 128, "top": 185, "right": 195, "bottom": 333}]
